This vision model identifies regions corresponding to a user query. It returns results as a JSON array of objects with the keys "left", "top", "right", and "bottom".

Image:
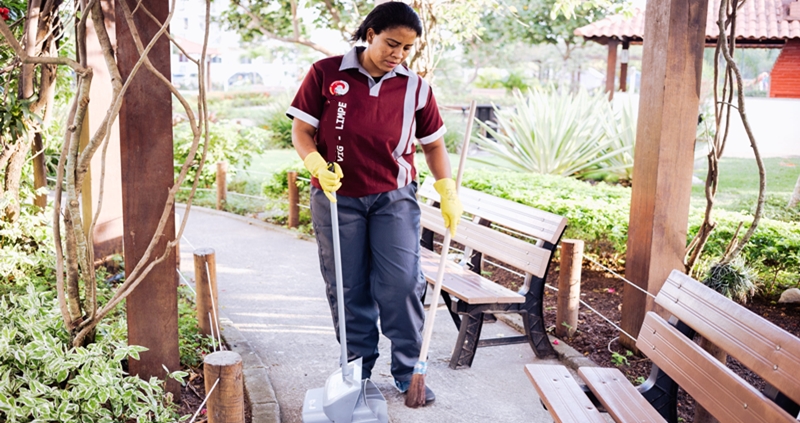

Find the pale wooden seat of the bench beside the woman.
[{"left": 420, "top": 248, "right": 525, "bottom": 304}]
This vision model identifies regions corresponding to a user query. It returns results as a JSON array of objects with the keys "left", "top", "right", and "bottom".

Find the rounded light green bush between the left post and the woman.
[{"left": 173, "top": 122, "right": 270, "bottom": 187}]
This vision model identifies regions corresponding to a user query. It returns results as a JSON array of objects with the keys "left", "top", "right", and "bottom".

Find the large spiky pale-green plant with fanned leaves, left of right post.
[{"left": 475, "top": 89, "right": 633, "bottom": 176}]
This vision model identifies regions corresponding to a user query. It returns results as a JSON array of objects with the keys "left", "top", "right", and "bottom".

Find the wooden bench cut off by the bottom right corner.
[{"left": 525, "top": 270, "right": 800, "bottom": 423}]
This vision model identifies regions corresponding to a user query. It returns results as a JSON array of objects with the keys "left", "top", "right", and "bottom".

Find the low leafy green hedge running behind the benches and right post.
[{"left": 456, "top": 170, "right": 800, "bottom": 293}]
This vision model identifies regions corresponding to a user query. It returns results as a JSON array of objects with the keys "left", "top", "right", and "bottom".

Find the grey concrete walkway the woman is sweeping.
[{"left": 177, "top": 207, "right": 576, "bottom": 423}]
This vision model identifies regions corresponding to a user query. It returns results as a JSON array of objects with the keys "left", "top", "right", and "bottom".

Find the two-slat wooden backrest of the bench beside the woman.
[{"left": 419, "top": 178, "right": 567, "bottom": 278}]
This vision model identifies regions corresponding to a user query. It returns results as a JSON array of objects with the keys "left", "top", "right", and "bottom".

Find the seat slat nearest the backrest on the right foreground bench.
[{"left": 578, "top": 367, "right": 666, "bottom": 422}]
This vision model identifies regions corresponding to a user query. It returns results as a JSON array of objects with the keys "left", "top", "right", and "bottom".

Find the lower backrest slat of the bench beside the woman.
[{"left": 419, "top": 204, "right": 550, "bottom": 277}]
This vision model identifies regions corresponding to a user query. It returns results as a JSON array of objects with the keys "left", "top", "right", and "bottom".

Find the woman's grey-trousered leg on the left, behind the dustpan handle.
[{"left": 311, "top": 187, "right": 378, "bottom": 378}]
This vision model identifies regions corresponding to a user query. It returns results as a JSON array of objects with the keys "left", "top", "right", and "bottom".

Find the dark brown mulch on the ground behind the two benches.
[{"left": 484, "top": 259, "right": 800, "bottom": 423}]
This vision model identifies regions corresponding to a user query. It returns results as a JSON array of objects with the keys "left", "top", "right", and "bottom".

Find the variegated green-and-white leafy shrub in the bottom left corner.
[{"left": 0, "top": 287, "right": 185, "bottom": 423}]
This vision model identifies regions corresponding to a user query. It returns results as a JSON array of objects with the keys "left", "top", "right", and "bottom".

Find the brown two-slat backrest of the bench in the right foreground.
[{"left": 636, "top": 270, "right": 800, "bottom": 423}]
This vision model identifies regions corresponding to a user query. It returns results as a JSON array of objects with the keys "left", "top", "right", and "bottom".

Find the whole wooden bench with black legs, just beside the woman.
[{"left": 419, "top": 178, "right": 567, "bottom": 369}]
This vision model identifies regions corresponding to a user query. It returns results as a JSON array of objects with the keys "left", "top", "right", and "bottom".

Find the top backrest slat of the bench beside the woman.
[{"left": 419, "top": 178, "right": 567, "bottom": 244}]
